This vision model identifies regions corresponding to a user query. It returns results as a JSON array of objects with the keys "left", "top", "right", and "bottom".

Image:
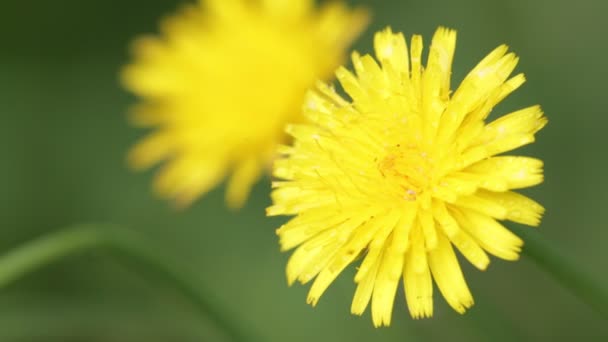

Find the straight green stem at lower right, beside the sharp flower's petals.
[{"left": 517, "top": 229, "right": 608, "bottom": 318}]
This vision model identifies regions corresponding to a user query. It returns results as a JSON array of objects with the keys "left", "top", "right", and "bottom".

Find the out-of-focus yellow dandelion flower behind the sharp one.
[{"left": 123, "top": 0, "right": 367, "bottom": 207}]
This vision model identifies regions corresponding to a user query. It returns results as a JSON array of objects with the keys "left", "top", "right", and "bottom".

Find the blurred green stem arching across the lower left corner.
[{"left": 0, "top": 224, "right": 250, "bottom": 341}]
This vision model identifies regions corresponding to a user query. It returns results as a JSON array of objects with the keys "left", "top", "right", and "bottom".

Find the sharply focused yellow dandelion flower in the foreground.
[{"left": 267, "top": 28, "right": 547, "bottom": 326}]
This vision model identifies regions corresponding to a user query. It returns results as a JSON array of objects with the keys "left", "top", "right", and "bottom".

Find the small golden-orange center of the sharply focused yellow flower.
[{"left": 378, "top": 145, "right": 434, "bottom": 201}]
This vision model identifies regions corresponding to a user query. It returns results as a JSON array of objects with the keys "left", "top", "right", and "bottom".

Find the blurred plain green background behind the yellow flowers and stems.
[{"left": 0, "top": 0, "right": 608, "bottom": 342}]
